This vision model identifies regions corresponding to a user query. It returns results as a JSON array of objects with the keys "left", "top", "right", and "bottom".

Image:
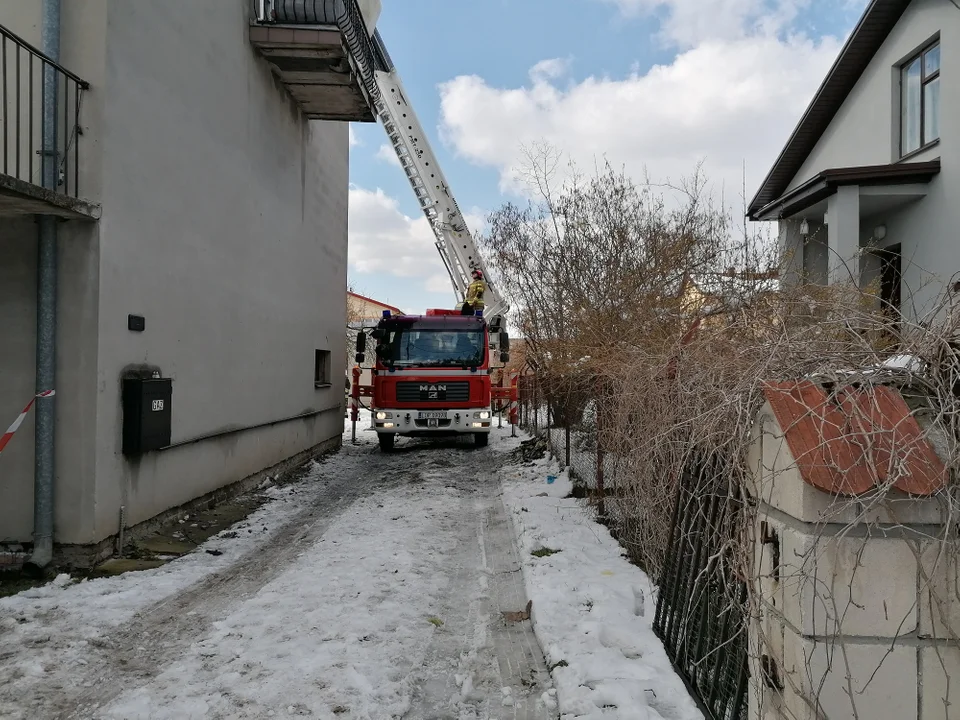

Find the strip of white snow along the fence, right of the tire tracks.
[{"left": 503, "top": 428, "right": 703, "bottom": 720}]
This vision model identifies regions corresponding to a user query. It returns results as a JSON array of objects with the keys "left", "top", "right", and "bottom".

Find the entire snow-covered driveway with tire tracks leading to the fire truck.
[{"left": 0, "top": 428, "right": 700, "bottom": 720}]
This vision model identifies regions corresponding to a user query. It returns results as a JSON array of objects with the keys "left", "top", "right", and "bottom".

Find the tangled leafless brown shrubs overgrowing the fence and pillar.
[{"left": 485, "top": 143, "right": 960, "bottom": 716}]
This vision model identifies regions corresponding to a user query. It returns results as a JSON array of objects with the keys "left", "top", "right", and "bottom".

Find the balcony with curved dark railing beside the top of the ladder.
[{"left": 250, "top": 0, "right": 379, "bottom": 122}]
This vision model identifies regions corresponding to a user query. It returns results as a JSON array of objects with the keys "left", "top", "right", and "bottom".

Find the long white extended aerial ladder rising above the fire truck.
[{"left": 373, "top": 30, "right": 509, "bottom": 325}]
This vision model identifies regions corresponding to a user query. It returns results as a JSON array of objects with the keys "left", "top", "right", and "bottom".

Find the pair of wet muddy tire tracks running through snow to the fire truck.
[{"left": 0, "top": 436, "right": 555, "bottom": 720}]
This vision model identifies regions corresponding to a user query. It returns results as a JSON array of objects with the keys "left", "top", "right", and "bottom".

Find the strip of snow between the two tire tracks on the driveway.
[{"left": 102, "top": 442, "right": 488, "bottom": 720}]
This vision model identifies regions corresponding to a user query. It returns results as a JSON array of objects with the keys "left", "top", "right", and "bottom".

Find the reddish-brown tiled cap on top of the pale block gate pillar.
[{"left": 763, "top": 380, "right": 948, "bottom": 496}]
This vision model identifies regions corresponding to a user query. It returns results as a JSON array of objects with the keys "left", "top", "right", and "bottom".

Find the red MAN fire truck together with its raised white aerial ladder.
[{"left": 342, "top": 31, "right": 516, "bottom": 451}]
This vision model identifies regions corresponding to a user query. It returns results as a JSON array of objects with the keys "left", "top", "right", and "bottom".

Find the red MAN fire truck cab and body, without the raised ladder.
[{"left": 351, "top": 310, "right": 516, "bottom": 452}]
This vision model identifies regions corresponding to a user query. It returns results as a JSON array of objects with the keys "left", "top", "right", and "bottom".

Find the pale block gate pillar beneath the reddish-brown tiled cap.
[{"left": 748, "top": 404, "right": 960, "bottom": 720}]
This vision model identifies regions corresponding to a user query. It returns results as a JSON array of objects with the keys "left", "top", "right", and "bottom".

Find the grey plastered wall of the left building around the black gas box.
[{"left": 0, "top": 0, "right": 349, "bottom": 543}]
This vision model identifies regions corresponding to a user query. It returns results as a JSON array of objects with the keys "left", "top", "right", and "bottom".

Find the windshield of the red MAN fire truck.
[{"left": 380, "top": 324, "right": 484, "bottom": 367}]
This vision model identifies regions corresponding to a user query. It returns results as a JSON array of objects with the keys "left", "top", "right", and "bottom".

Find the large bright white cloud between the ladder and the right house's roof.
[{"left": 440, "top": 18, "right": 840, "bottom": 205}]
